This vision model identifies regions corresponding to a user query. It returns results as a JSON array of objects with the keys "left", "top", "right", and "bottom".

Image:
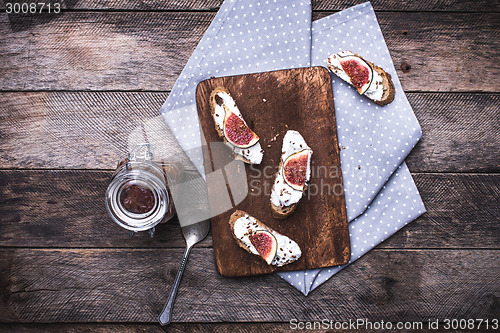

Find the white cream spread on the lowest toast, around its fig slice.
[{"left": 233, "top": 215, "right": 302, "bottom": 267}]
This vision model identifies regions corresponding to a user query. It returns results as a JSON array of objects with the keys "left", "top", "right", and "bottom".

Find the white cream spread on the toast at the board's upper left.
[{"left": 213, "top": 92, "right": 264, "bottom": 164}]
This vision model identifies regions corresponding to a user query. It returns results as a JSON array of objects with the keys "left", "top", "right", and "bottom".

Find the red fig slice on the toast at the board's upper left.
[{"left": 224, "top": 105, "right": 259, "bottom": 148}]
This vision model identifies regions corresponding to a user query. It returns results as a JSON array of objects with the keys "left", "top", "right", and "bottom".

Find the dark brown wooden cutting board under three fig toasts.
[{"left": 196, "top": 67, "right": 351, "bottom": 276}]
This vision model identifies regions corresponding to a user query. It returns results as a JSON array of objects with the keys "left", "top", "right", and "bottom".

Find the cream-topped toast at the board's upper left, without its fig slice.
[{"left": 210, "top": 87, "right": 263, "bottom": 164}]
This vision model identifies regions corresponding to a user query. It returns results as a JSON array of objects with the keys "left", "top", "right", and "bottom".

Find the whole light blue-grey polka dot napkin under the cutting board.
[{"left": 160, "top": 0, "right": 425, "bottom": 295}]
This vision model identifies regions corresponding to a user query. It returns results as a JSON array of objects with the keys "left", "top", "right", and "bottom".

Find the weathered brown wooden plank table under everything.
[{"left": 0, "top": 0, "right": 500, "bottom": 332}]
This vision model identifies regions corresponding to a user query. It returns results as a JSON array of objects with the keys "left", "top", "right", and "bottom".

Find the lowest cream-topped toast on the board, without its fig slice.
[{"left": 229, "top": 210, "right": 302, "bottom": 267}]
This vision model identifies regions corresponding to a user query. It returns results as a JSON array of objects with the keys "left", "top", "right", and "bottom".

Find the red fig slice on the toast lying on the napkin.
[{"left": 338, "top": 54, "right": 373, "bottom": 94}]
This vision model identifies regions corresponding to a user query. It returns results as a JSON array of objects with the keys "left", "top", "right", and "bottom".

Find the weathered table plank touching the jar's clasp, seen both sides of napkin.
[{"left": 0, "top": 92, "right": 500, "bottom": 172}]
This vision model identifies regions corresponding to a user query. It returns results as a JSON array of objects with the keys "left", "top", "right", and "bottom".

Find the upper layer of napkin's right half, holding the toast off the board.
[{"left": 311, "top": 3, "right": 422, "bottom": 220}]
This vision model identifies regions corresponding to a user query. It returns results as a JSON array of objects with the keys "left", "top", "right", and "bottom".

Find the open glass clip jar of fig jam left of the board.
[{"left": 106, "top": 143, "right": 175, "bottom": 235}]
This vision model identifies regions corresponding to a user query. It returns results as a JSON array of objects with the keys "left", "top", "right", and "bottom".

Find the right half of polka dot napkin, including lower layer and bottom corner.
[{"left": 278, "top": 3, "right": 425, "bottom": 295}]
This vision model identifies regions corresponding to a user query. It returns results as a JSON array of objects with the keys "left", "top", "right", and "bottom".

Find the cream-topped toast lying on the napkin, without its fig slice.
[{"left": 326, "top": 51, "right": 396, "bottom": 106}]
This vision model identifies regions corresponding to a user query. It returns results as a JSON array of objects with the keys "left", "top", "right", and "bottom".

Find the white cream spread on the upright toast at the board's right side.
[{"left": 271, "top": 130, "right": 312, "bottom": 207}]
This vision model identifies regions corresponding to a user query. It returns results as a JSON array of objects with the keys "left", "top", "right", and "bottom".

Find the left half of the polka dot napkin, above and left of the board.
[{"left": 160, "top": 0, "right": 311, "bottom": 176}]
